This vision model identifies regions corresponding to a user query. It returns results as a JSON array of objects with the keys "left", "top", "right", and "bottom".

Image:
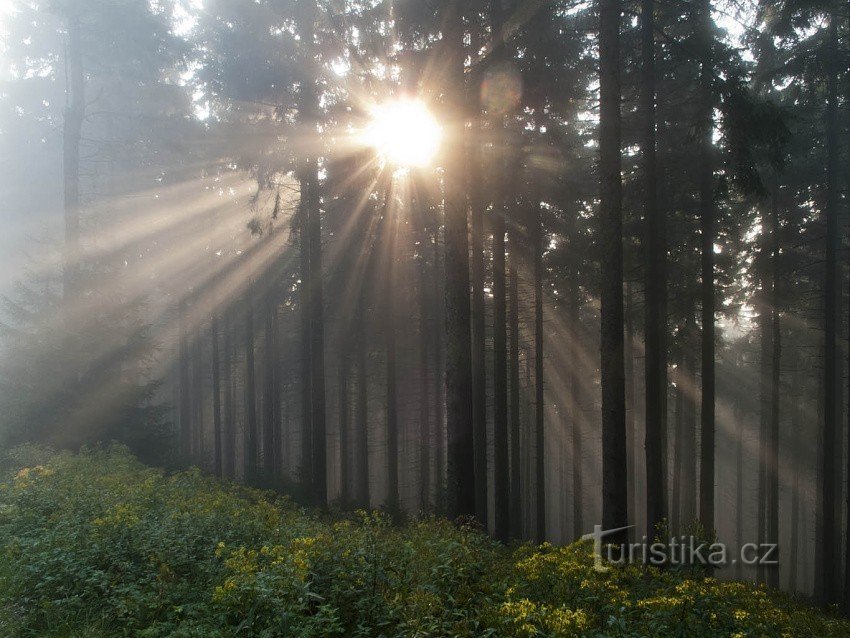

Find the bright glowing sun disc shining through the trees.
[{"left": 363, "top": 99, "right": 443, "bottom": 167}]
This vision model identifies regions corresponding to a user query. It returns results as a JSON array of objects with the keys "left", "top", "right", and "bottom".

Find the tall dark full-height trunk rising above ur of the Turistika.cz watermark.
[{"left": 640, "top": 0, "right": 664, "bottom": 538}]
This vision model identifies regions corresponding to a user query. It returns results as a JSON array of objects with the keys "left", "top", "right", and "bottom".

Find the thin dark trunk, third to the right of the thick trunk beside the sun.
[{"left": 506, "top": 238, "right": 524, "bottom": 538}]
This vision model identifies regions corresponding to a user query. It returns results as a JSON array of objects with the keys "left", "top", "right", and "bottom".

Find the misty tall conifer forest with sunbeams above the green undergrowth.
[{"left": 0, "top": 0, "right": 850, "bottom": 602}]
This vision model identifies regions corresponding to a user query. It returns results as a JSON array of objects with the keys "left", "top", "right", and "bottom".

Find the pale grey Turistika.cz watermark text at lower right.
[{"left": 581, "top": 525, "right": 779, "bottom": 572}]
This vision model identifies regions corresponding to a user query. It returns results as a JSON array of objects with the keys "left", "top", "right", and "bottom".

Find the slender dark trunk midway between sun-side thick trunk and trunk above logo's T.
[{"left": 528, "top": 204, "right": 546, "bottom": 543}]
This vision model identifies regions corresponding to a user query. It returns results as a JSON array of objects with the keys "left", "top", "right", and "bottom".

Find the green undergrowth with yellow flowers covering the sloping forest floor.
[{"left": 0, "top": 447, "right": 850, "bottom": 638}]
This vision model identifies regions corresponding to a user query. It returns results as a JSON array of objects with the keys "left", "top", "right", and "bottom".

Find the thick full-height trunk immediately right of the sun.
[{"left": 443, "top": 0, "right": 475, "bottom": 517}]
